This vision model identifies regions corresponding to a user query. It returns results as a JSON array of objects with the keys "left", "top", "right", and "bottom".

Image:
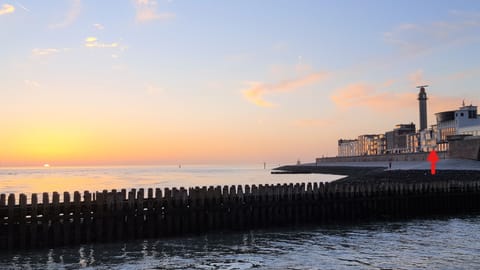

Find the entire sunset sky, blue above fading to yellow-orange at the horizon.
[{"left": 0, "top": 0, "right": 480, "bottom": 166}]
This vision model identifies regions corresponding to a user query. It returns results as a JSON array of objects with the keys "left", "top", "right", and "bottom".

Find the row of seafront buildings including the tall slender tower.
[{"left": 338, "top": 85, "right": 480, "bottom": 157}]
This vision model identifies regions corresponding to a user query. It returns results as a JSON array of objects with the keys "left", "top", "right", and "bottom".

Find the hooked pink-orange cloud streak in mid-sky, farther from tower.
[{"left": 242, "top": 72, "right": 329, "bottom": 107}]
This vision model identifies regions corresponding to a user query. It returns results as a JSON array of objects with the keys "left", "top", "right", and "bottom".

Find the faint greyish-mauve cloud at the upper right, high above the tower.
[{"left": 383, "top": 12, "right": 480, "bottom": 54}]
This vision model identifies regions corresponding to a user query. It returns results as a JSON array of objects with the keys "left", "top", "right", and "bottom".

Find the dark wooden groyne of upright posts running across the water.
[{"left": 0, "top": 181, "right": 480, "bottom": 250}]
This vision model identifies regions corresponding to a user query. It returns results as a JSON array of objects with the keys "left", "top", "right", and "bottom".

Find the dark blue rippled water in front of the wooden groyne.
[{"left": 0, "top": 215, "right": 480, "bottom": 269}]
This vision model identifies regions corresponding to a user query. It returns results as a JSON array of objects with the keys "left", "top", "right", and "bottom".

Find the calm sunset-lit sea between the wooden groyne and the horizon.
[{"left": 0, "top": 165, "right": 341, "bottom": 197}]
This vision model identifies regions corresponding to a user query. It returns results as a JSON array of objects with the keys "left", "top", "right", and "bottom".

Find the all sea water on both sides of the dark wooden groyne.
[{"left": 0, "top": 165, "right": 480, "bottom": 269}]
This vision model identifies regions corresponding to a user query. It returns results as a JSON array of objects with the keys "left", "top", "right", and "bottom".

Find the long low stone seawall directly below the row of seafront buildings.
[{"left": 316, "top": 152, "right": 448, "bottom": 164}]
